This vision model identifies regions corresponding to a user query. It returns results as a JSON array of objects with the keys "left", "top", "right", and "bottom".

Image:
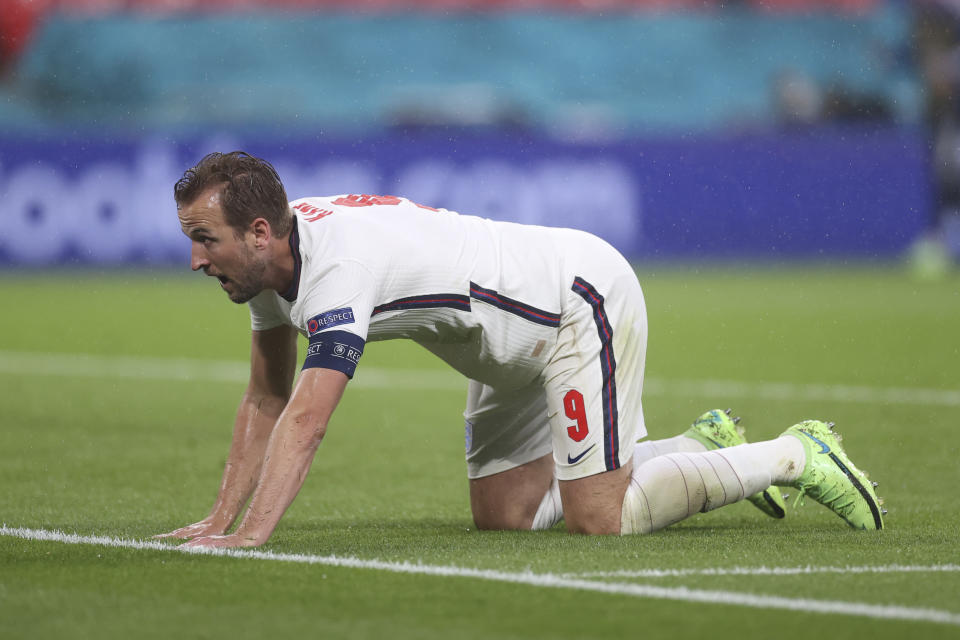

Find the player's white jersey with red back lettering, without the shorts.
[{"left": 250, "top": 195, "right": 596, "bottom": 386}]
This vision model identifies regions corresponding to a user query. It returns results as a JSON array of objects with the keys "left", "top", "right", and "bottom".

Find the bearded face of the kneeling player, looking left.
[{"left": 177, "top": 188, "right": 267, "bottom": 304}]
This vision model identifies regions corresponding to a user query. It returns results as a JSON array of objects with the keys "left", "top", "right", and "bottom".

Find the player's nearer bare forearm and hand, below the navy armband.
[{"left": 180, "top": 369, "right": 348, "bottom": 547}]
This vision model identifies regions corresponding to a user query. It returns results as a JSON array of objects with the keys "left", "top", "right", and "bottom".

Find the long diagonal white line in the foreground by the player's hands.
[{"left": 0, "top": 525, "right": 960, "bottom": 626}]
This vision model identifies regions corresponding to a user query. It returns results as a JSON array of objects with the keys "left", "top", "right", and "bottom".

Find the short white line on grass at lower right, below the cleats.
[{"left": 563, "top": 564, "right": 960, "bottom": 578}]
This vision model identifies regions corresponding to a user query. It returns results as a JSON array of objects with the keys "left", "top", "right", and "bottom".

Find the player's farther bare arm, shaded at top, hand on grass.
[{"left": 157, "top": 326, "right": 297, "bottom": 538}]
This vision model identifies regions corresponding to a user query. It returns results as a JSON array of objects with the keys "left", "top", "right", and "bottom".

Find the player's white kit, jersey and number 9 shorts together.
[{"left": 249, "top": 195, "right": 646, "bottom": 479}]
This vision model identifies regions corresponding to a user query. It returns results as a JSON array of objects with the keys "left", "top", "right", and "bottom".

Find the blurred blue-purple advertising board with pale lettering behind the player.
[{"left": 0, "top": 128, "right": 932, "bottom": 266}]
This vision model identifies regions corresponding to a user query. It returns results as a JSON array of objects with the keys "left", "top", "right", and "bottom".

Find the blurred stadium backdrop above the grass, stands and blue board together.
[{"left": 0, "top": 0, "right": 960, "bottom": 272}]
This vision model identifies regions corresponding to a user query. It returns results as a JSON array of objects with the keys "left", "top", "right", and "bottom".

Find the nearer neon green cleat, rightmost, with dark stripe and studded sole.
[{"left": 783, "top": 420, "right": 886, "bottom": 530}]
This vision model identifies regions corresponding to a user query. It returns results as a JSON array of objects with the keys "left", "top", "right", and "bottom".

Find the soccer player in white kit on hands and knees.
[{"left": 158, "top": 152, "right": 883, "bottom": 547}]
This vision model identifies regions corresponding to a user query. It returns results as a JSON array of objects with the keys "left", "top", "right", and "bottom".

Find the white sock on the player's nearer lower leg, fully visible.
[{"left": 620, "top": 436, "right": 805, "bottom": 534}]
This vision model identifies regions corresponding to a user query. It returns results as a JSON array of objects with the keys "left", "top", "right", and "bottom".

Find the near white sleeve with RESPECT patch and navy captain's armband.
[{"left": 300, "top": 261, "right": 376, "bottom": 378}]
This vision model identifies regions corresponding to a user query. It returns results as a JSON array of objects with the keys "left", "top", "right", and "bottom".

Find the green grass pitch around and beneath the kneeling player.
[{"left": 0, "top": 266, "right": 960, "bottom": 639}]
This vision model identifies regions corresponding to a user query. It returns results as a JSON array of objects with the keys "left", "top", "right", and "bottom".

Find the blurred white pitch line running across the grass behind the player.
[{"left": 0, "top": 351, "right": 960, "bottom": 407}]
